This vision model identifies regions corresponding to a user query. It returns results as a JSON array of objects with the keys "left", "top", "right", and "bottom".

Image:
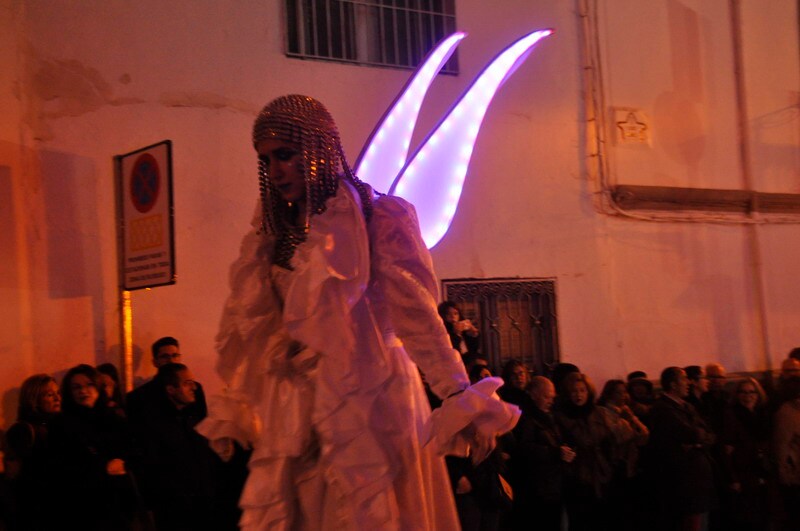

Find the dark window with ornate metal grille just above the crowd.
[{"left": 442, "top": 279, "right": 559, "bottom": 375}]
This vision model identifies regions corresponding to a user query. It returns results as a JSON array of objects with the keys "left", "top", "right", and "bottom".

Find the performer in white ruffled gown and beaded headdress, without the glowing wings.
[{"left": 198, "top": 95, "right": 519, "bottom": 530}]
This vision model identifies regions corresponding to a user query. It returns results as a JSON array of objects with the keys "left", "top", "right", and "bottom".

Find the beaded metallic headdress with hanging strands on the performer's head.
[{"left": 253, "top": 94, "right": 372, "bottom": 268}]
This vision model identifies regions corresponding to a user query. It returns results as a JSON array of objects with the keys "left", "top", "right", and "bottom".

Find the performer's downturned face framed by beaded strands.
[{"left": 256, "top": 138, "right": 306, "bottom": 202}]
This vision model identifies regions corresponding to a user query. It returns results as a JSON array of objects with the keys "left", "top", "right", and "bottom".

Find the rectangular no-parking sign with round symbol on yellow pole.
[{"left": 114, "top": 140, "right": 175, "bottom": 290}]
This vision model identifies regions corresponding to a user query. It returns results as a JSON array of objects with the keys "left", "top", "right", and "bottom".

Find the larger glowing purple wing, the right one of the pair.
[{"left": 389, "top": 30, "right": 553, "bottom": 249}]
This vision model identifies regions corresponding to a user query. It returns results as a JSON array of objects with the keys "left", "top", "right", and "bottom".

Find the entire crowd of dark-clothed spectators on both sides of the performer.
[{"left": 0, "top": 318, "right": 800, "bottom": 531}]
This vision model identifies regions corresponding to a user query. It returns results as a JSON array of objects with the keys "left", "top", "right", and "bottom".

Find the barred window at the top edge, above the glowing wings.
[{"left": 286, "top": 0, "right": 458, "bottom": 74}]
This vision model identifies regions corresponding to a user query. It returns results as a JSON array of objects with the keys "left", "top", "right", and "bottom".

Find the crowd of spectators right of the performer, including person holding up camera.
[{"left": 433, "top": 303, "right": 800, "bottom": 531}]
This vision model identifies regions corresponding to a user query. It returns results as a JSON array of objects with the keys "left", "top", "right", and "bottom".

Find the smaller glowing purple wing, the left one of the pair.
[{"left": 356, "top": 32, "right": 466, "bottom": 192}]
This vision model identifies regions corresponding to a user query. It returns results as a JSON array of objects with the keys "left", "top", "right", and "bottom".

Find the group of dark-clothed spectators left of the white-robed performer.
[{"left": 0, "top": 337, "right": 247, "bottom": 531}]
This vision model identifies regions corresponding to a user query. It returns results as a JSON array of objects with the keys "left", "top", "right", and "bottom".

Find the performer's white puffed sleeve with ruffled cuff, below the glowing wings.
[{"left": 369, "top": 196, "right": 520, "bottom": 460}]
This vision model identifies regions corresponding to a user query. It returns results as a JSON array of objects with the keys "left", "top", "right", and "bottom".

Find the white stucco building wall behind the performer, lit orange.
[{"left": 0, "top": 0, "right": 800, "bottom": 425}]
